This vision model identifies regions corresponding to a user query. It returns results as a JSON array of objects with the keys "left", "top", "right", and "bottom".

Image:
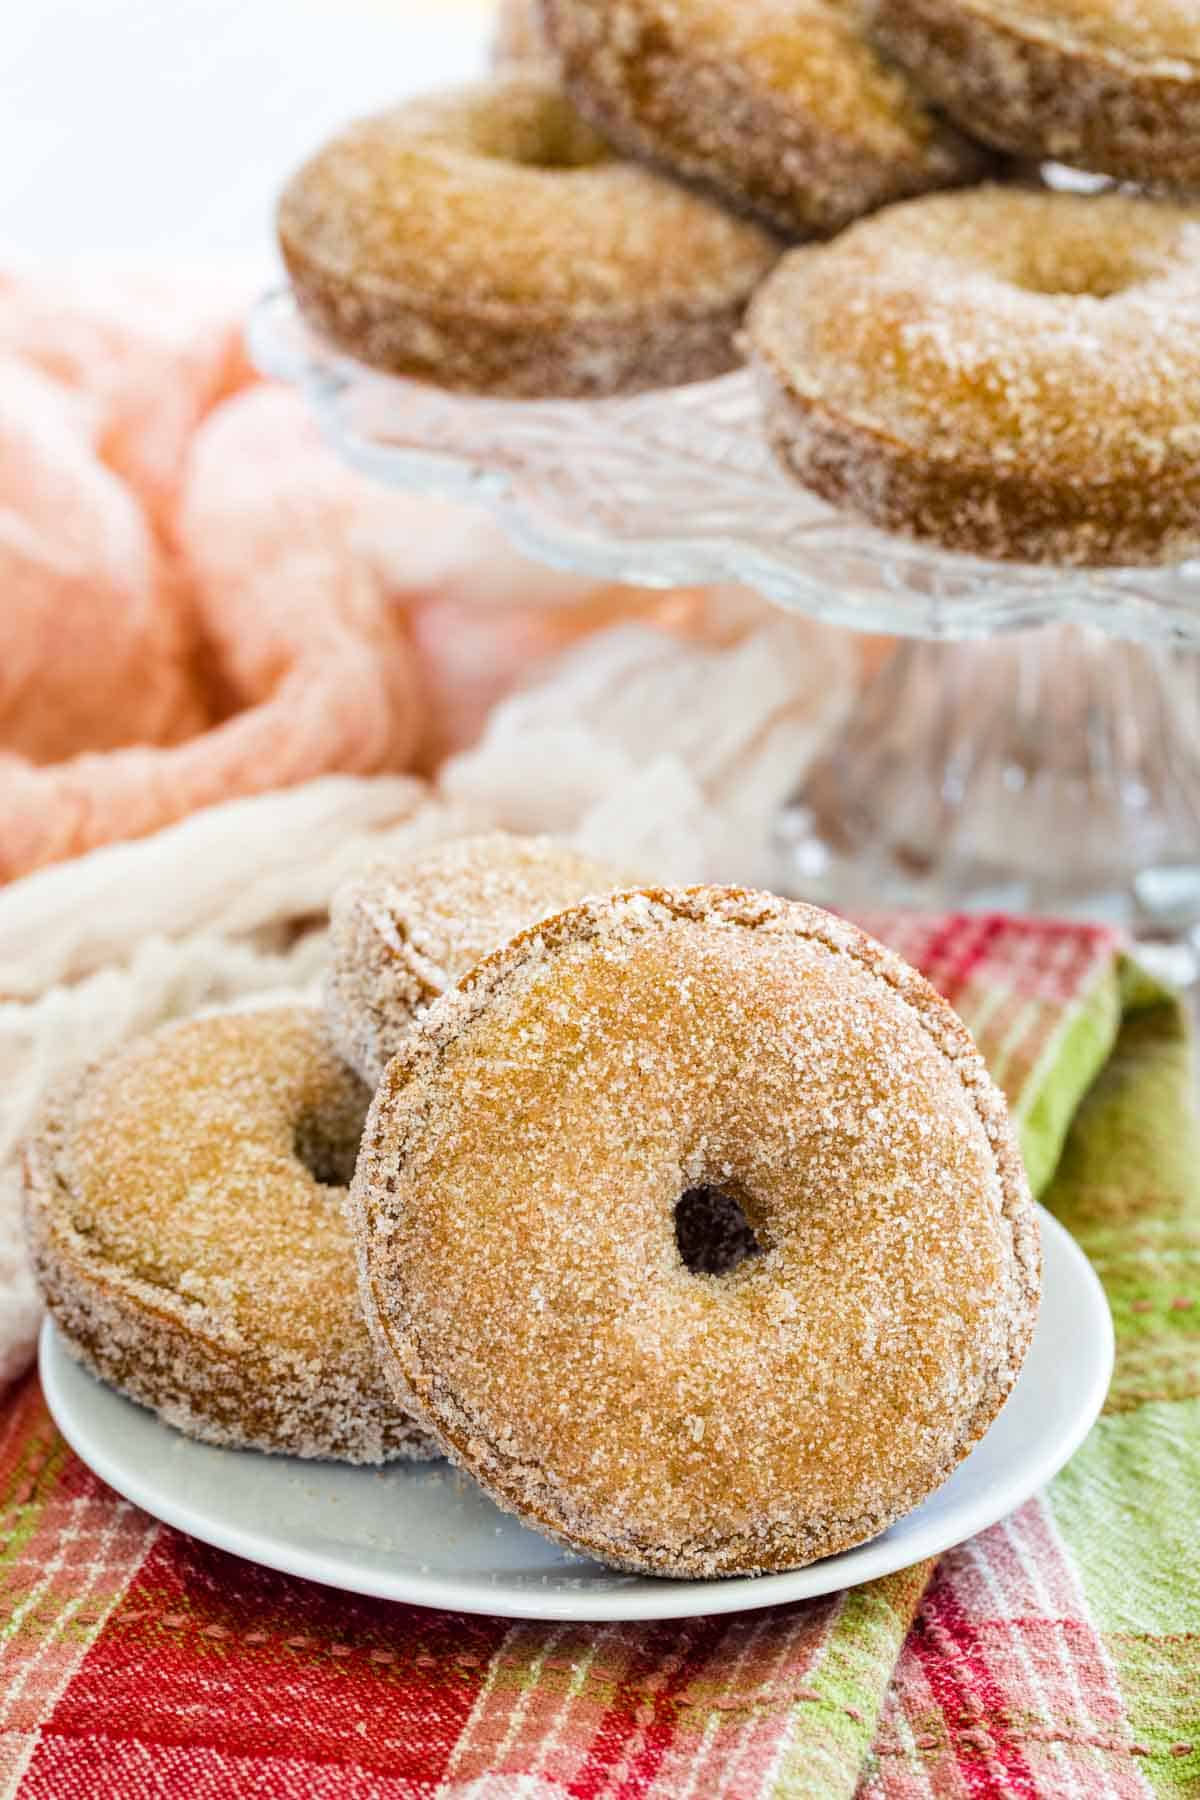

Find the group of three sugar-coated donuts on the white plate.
[{"left": 25, "top": 837, "right": 1040, "bottom": 1577}]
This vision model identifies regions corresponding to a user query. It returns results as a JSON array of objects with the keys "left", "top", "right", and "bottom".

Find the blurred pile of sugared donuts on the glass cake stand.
[{"left": 279, "top": 0, "right": 1200, "bottom": 565}]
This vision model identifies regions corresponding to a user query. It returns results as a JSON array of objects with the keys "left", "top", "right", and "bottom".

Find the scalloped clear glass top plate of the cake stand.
[{"left": 246, "top": 288, "right": 1200, "bottom": 644}]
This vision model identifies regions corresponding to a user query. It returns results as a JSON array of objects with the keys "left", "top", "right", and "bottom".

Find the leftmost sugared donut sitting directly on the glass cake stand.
[{"left": 277, "top": 68, "right": 779, "bottom": 398}]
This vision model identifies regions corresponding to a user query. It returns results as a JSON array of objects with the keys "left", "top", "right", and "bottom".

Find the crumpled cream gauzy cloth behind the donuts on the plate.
[{"left": 0, "top": 596, "right": 855, "bottom": 1384}]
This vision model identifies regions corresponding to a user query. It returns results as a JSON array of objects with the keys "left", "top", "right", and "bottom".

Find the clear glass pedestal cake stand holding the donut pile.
[{"left": 250, "top": 290, "right": 1200, "bottom": 945}]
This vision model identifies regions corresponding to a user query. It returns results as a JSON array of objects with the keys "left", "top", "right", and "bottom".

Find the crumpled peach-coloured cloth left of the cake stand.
[{"left": 0, "top": 270, "right": 705, "bottom": 880}]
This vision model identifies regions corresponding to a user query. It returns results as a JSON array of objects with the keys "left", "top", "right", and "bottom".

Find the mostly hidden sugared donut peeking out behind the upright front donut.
[{"left": 326, "top": 832, "right": 626, "bottom": 1087}]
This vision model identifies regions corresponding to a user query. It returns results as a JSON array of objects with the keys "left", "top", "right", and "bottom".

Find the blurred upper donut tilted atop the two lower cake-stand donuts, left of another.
[{"left": 543, "top": 0, "right": 990, "bottom": 238}]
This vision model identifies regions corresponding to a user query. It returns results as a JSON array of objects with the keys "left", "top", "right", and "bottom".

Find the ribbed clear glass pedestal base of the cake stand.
[{"left": 775, "top": 625, "right": 1200, "bottom": 972}]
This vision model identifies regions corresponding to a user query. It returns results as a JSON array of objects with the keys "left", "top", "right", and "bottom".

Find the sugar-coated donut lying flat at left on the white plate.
[{"left": 25, "top": 1006, "right": 437, "bottom": 1463}]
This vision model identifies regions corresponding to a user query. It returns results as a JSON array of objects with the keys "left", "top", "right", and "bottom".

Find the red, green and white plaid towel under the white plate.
[{"left": 0, "top": 916, "right": 1200, "bottom": 1800}]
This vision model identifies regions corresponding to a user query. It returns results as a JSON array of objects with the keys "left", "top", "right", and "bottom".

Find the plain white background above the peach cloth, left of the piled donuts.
[{"left": 0, "top": 0, "right": 488, "bottom": 263}]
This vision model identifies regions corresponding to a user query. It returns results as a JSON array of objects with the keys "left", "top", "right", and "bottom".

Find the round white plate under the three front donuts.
[{"left": 41, "top": 1211, "right": 1114, "bottom": 1620}]
